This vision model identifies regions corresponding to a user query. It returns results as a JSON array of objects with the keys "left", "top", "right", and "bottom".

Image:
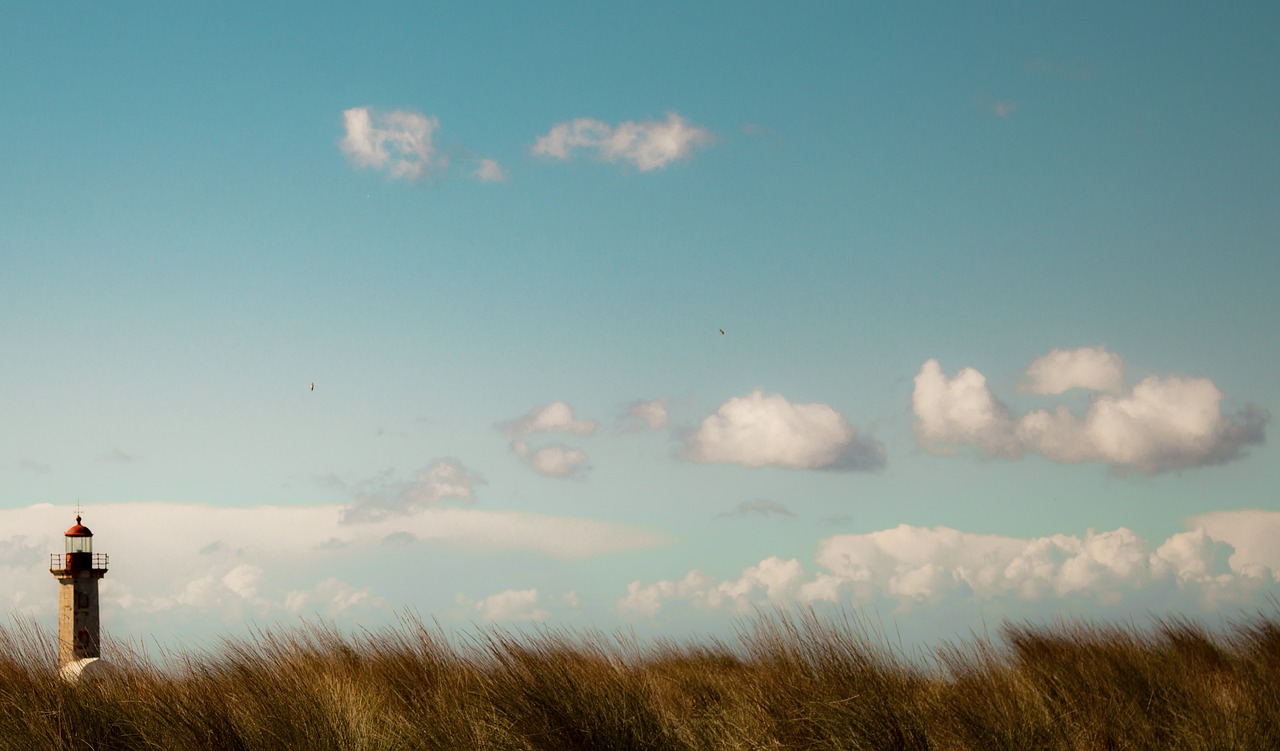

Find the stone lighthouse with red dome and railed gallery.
[{"left": 49, "top": 514, "right": 108, "bottom": 670}]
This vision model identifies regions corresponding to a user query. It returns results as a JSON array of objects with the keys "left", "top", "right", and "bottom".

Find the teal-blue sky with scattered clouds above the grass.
[{"left": 0, "top": 3, "right": 1280, "bottom": 652}]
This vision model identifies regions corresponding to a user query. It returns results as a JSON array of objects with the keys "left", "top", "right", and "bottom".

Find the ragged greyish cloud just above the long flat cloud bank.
[{"left": 342, "top": 458, "right": 484, "bottom": 523}]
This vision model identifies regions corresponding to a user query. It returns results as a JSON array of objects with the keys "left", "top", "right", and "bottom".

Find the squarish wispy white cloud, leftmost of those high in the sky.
[{"left": 340, "top": 107, "right": 448, "bottom": 180}]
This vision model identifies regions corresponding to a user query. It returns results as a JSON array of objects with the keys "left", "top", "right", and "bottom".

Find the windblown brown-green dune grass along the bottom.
[{"left": 0, "top": 613, "right": 1280, "bottom": 751}]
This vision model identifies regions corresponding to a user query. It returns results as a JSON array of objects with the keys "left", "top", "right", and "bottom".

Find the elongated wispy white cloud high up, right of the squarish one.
[{"left": 532, "top": 113, "right": 714, "bottom": 171}]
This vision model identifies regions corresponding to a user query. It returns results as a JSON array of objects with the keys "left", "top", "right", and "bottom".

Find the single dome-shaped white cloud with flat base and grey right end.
[{"left": 684, "top": 389, "right": 884, "bottom": 470}]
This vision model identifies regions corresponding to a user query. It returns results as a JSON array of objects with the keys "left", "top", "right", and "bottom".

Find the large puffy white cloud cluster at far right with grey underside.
[{"left": 911, "top": 351, "right": 1268, "bottom": 472}]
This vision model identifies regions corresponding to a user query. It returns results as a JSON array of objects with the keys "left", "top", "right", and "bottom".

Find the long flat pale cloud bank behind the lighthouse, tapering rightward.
[{"left": 0, "top": 503, "right": 667, "bottom": 631}]
